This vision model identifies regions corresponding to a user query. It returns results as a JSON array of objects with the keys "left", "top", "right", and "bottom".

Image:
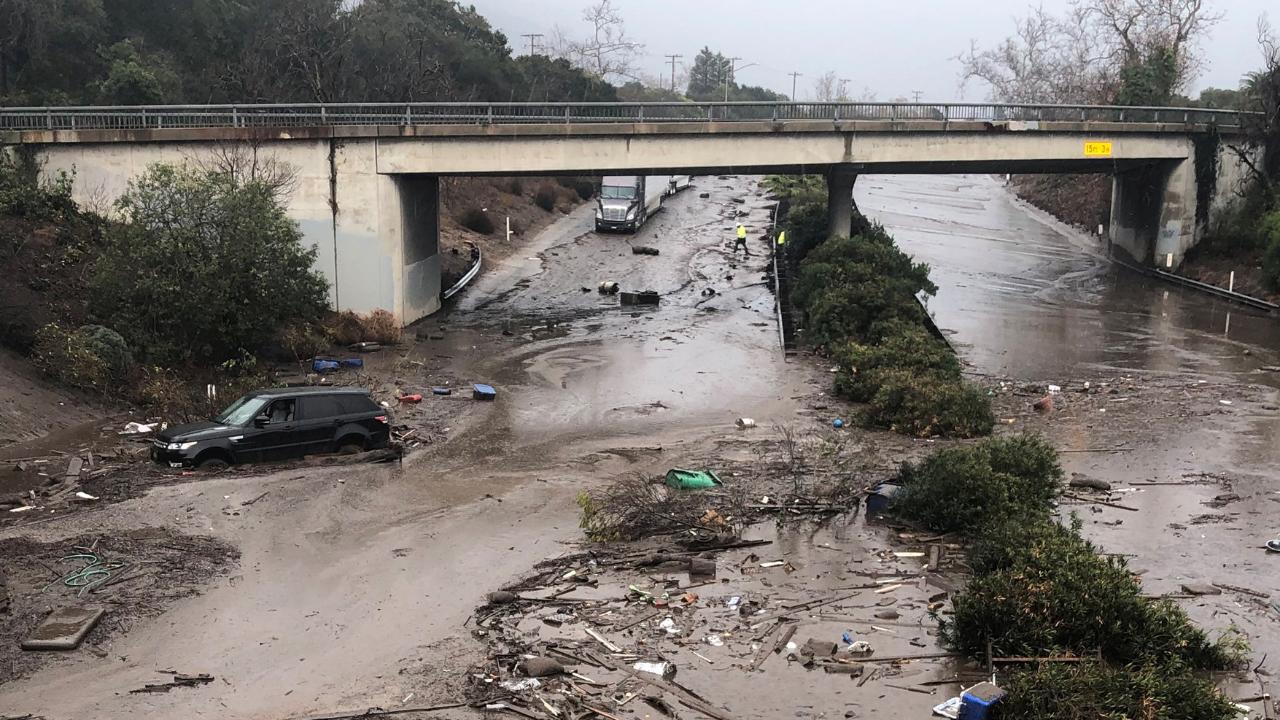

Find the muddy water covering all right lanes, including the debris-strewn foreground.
[{"left": 855, "top": 177, "right": 1280, "bottom": 681}]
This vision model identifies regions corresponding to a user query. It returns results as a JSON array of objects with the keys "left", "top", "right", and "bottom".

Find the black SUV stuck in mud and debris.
[{"left": 151, "top": 387, "right": 390, "bottom": 469}]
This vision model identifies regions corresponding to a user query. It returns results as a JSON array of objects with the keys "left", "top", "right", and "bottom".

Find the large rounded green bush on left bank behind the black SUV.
[{"left": 90, "top": 165, "right": 328, "bottom": 365}]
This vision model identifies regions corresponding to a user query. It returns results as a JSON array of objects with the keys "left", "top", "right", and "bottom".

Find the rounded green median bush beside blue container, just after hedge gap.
[{"left": 893, "top": 434, "right": 1062, "bottom": 530}]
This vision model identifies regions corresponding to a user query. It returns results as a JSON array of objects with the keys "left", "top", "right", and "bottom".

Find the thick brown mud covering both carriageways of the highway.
[{"left": 0, "top": 177, "right": 1280, "bottom": 719}]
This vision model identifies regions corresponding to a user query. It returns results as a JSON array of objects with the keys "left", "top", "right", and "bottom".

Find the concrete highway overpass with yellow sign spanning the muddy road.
[{"left": 0, "top": 102, "right": 1244, "bottom": 323}]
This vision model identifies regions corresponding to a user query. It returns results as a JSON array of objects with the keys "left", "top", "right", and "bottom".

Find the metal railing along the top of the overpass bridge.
[{"left": 0, "top": 102, "right": 1251, "bottom": 131}]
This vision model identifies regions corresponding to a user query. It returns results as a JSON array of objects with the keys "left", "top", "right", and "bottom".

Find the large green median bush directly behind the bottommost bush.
[{"left": 940, "top": 515, "right": 1243, "bottom": 670}]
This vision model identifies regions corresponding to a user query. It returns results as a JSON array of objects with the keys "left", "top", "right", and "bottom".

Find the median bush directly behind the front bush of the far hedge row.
[{"left": 832, "top": 323, "right": 960, "bottom": 402}]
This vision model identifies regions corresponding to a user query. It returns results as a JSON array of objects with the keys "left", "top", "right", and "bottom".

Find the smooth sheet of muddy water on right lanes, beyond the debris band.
[{"left": 855, "top": 176, "right": 1280, "bottom": 387}]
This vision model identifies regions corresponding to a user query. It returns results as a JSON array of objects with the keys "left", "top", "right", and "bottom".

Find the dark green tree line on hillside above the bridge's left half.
[{"left": 0, "top": 0, "right": 617, "bottom": 105}]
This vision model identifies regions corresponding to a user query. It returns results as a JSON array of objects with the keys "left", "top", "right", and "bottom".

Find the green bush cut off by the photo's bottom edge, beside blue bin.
[{"left": 995, "top": 664, "right": 1239, "bottom": 720}]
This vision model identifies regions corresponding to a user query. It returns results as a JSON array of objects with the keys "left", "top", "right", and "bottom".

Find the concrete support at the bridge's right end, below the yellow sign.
[{"left": 1111, "top": 158, "right": 1197, "bottom": 269}]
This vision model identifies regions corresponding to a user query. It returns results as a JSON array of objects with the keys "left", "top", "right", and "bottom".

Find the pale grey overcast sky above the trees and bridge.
[{"left": 476, "top": 0, "right": 1280, "bottom": 101}]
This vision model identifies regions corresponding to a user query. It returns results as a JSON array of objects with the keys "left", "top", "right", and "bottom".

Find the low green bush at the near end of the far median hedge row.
[{"left": 865, "top": 369, "right": 996, "bottom": 438}]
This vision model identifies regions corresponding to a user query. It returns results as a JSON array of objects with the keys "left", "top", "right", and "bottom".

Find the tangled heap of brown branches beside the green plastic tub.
[{"left": 577, "top": 474, "right": 746, "bottom": 541}]
